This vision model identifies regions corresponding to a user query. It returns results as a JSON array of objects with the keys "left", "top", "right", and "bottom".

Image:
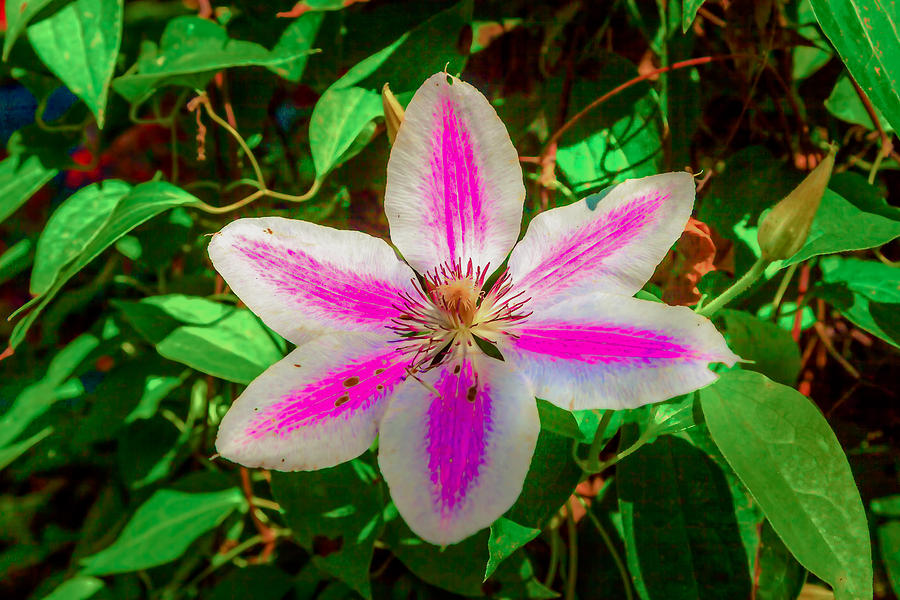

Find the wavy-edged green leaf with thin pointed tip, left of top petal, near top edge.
[{"left": 112, "top": 16, "right": 315, "bottom": 103}]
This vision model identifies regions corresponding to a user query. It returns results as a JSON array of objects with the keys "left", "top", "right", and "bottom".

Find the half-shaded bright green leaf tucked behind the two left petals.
[{"left": 116, "top": 294, "right": 282, "bottom": 384}]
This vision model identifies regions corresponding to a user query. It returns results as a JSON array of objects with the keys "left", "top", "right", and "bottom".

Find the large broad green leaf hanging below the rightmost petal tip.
[{"left": 700, "top": 371, "right": 872, "bottom": 600}]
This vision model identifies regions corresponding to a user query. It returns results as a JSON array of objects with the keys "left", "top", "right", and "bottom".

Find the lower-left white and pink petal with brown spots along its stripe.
[{"left": 216, "top": 333, "right": 412, "bottom": 471}]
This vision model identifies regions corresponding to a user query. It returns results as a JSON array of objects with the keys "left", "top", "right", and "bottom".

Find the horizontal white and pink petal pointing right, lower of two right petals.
[{"left": 498, "top": 293, "right": 740, "bottom": 410}]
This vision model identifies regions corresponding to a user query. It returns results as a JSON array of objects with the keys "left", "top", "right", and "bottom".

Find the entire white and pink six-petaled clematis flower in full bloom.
[{"left": 209, "top": 73, "right": 737, "bottom": 544}]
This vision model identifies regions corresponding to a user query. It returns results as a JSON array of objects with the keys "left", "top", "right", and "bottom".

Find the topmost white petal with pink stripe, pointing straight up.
[{"left": 384, "top": 73, "right": 525, "bottom": 273}]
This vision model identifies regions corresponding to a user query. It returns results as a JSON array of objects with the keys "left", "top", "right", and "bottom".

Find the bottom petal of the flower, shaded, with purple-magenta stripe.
[{"left": 378, "top": 354, "right": 540, "bottom": 545}]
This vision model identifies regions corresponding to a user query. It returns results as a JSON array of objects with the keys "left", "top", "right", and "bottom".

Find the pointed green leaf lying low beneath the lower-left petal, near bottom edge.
[{"left": 81, "top": 488, "right": 246, "bottom": 575}]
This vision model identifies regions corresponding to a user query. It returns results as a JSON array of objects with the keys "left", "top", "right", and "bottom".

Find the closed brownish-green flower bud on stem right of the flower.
[{"left": 756, "top": 146, "right": 837, "bottom": 261}]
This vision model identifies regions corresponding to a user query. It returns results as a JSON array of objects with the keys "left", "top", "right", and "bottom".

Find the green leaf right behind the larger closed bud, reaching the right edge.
[{"left": 784, "top": 173, "right": 900, "bottom": 266}]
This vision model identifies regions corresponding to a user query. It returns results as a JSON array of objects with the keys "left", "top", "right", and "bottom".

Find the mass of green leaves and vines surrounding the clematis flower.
[{"left": 0, "top": 0, "right": 900, "bottom": 600}]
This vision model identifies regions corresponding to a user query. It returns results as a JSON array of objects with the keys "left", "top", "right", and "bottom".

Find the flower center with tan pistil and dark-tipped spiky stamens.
[{"left": 391, "top": 260, "right": 531, "bottom": 370}]
